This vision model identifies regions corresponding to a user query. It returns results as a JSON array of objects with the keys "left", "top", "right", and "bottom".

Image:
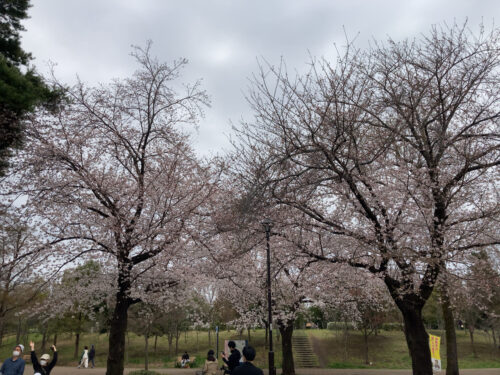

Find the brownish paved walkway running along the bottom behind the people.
[{"left": 24, "top": 365, "right": 500, "bottom": 375}]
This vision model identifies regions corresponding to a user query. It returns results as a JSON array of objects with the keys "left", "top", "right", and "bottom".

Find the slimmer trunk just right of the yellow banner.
[{"left": 439, "top": 282, "right": 459, "bottom": 375}]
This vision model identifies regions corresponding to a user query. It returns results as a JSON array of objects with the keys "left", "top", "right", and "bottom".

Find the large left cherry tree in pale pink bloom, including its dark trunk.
[{"left": 5, "top": 44, "right": 213, "bottom": 375}]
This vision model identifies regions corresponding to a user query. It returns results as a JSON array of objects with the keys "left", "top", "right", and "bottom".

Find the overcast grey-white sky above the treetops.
[{"left": 23, "top": 0, "right": 500, "bottom": 155}]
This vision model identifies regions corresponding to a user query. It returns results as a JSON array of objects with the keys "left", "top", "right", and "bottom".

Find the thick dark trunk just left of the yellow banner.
[{"left": 397, "top": 306, "right": 432, "bottom": 375}]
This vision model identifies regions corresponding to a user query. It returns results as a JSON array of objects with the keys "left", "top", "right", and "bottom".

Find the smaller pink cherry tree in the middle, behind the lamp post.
[{"left": 205, "top": 207, "right": 387, "bottom": 375}]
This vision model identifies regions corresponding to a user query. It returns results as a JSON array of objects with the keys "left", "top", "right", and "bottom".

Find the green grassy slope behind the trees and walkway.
[{"left": 0, "top": 330, "right": 500, "bottom": 369}]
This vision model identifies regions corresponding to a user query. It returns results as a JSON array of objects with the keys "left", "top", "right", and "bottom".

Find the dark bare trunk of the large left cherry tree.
[{"left": 106, "top": 288, "right": 130, "bottom": 375}]
